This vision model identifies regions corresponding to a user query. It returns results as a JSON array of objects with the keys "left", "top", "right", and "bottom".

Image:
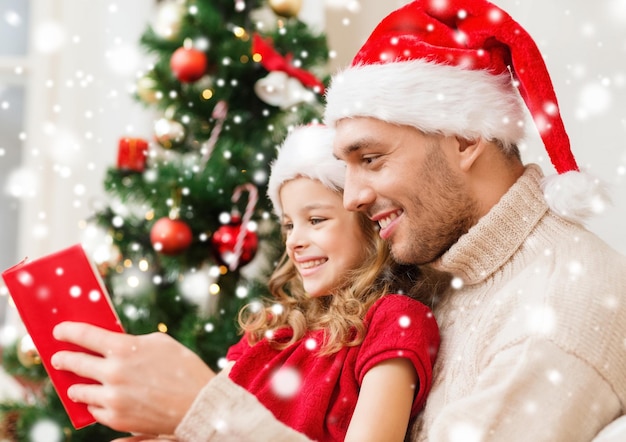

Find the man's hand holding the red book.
[{"left": 52, "top": 322, "right": 215, "bottom": 435}]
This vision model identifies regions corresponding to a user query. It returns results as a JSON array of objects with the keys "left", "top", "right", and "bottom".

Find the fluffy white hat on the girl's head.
[{"left": 267, "top": 124, "right": 346, "bottom": 218}]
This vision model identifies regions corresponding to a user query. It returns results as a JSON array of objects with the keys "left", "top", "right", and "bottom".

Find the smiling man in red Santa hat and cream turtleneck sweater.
[{"left": 52, "top": 0, "right": 626, "bottom": 442}]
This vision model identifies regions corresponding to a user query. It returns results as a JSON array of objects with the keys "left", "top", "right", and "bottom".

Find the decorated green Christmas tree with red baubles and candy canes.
[{"left": 0, "top": 0, "right": 329, "bottom": 442}]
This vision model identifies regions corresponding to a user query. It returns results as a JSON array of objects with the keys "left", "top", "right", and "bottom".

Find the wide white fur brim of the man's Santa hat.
[{"left": 324, "top": 59, "right": 525, "bottom": 145}]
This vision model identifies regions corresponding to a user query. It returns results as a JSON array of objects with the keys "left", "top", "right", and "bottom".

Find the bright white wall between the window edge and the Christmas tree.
[{"left": 18, "top": 0, "right": 153, "bottom": 257}]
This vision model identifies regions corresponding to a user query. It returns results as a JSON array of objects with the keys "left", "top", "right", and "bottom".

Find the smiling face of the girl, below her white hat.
[{"left": 279, "top": 178, "right": 366, "bottom": 297}]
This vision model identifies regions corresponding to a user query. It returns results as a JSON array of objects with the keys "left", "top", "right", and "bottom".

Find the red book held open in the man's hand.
[{"left": 2, "top": 245, "right": 124, "bottom": 429}]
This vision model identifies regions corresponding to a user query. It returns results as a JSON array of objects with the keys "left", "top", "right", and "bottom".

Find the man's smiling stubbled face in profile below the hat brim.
[{"left": 334, "top": 118, "right": 477, "bottom": 264}]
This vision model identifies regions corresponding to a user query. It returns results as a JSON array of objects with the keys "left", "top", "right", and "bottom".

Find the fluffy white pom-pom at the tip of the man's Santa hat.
[{"left": 541, "top": 171, "right": 611, "bottom": 224}]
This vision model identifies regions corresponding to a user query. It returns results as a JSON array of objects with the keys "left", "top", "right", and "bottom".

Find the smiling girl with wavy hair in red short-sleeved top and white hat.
[{"left": 227, "top": 125, "right": 439, "bottom": 442}]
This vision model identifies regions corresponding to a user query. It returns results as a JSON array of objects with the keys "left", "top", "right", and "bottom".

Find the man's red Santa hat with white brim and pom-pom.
[{"left": 325, "top": 0, "right": 607, "bottom": 221}]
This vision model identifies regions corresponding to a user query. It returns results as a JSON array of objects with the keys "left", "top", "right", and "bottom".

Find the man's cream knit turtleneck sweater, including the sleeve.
[{"left": 176, "top": 165, "right": 626, "bottom": 442}]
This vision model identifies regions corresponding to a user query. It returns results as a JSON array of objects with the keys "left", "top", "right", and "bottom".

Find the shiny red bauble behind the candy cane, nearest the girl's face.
[{"left": 211, "top": 218, "right": 259, "bottom": 270}]
